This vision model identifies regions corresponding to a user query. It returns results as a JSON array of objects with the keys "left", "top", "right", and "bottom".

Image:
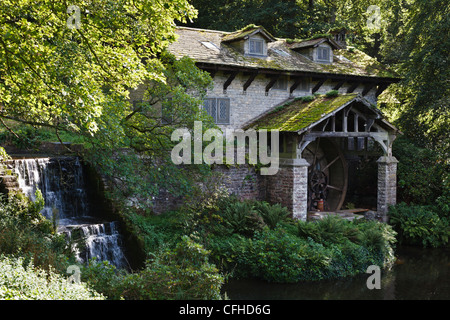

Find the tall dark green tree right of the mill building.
[{"left": 381, "top": 0, "right": 450, "bottom": 158}]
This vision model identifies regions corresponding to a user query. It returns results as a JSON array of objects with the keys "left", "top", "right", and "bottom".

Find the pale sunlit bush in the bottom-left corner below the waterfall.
[{"left": 0, "top": 256, "right": 104, "bottom": 300}]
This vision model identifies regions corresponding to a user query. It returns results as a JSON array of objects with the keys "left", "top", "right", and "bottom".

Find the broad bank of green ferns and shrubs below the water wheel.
[{"left": 208, "top": 217, "right": 395, "bottom": 282}]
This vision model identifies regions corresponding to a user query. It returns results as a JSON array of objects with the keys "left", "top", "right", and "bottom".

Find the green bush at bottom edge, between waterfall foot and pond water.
[{"left": 82, "top": 236, "right": 223, "bottom": 300}]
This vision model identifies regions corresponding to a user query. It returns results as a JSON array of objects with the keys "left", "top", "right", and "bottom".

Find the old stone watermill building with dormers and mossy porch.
[{"left": 164, "top": 25, "right": 399, "bottom": 219}]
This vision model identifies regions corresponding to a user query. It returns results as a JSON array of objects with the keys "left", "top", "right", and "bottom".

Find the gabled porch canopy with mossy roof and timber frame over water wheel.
[{"left": 245, "top": 93, "right": 400, "bottom": 156}]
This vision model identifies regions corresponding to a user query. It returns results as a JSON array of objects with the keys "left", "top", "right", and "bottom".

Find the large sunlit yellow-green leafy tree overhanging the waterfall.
[{"left": 0, "top": 0, "right": 216, "bottom": 209}]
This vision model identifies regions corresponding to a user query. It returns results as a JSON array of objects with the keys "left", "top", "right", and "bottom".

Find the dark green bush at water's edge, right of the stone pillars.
[{"left": 389, "top": 202, "right": 450, "bottom": 248}]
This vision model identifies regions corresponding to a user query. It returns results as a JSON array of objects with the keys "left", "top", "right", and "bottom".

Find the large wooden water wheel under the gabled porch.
[{"left": 302, "top": 138, "right": 348, "bottom": 211}]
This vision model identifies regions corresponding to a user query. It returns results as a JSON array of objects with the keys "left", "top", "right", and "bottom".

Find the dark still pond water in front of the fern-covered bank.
[{"left": 223, "top": 247, "right": 450, "bottom": 300}]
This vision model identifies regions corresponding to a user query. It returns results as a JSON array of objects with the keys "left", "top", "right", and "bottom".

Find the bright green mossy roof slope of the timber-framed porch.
[{"left": 245, "top": 93, "right": 359, "bottom": 132}]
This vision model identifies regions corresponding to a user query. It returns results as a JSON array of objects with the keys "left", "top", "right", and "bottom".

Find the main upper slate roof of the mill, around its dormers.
[{"left": 168, "top": 27, "right": 397, "bottom": 79}]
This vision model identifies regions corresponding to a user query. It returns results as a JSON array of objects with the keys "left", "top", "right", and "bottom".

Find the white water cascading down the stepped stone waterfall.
[{"left": 12, "top": 157, "right": 127, "bottom": 268}]
